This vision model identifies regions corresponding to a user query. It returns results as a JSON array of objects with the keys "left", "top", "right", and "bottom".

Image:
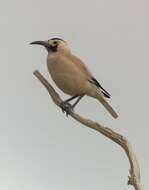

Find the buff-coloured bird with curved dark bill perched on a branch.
[{"left": 30, "top": 37, "right": 118, "bottom": 118}]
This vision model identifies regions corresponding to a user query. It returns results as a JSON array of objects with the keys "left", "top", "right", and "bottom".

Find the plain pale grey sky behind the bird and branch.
[{"left": 0, "top": 0, "right": 149, "bottom": 190}]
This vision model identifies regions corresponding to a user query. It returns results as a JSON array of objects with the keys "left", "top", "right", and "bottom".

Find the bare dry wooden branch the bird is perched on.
[{"left": 34, "top": 71, "right": 143, "bottom": 190}]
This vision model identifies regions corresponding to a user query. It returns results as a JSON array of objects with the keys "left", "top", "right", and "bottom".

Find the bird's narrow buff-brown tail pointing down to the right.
[{"left": 95, "top": 91, "right": 118, "bottom": 119}]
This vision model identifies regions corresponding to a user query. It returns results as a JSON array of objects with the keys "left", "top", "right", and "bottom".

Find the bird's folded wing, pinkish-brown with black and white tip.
[{"left": 71, "top": 55, "right": 111, "bottom": 98}]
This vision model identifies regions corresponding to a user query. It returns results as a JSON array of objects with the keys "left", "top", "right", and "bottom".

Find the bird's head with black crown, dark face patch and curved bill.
[{"left": 30, "top": 38, "right": 70, "bottom": 53}]
